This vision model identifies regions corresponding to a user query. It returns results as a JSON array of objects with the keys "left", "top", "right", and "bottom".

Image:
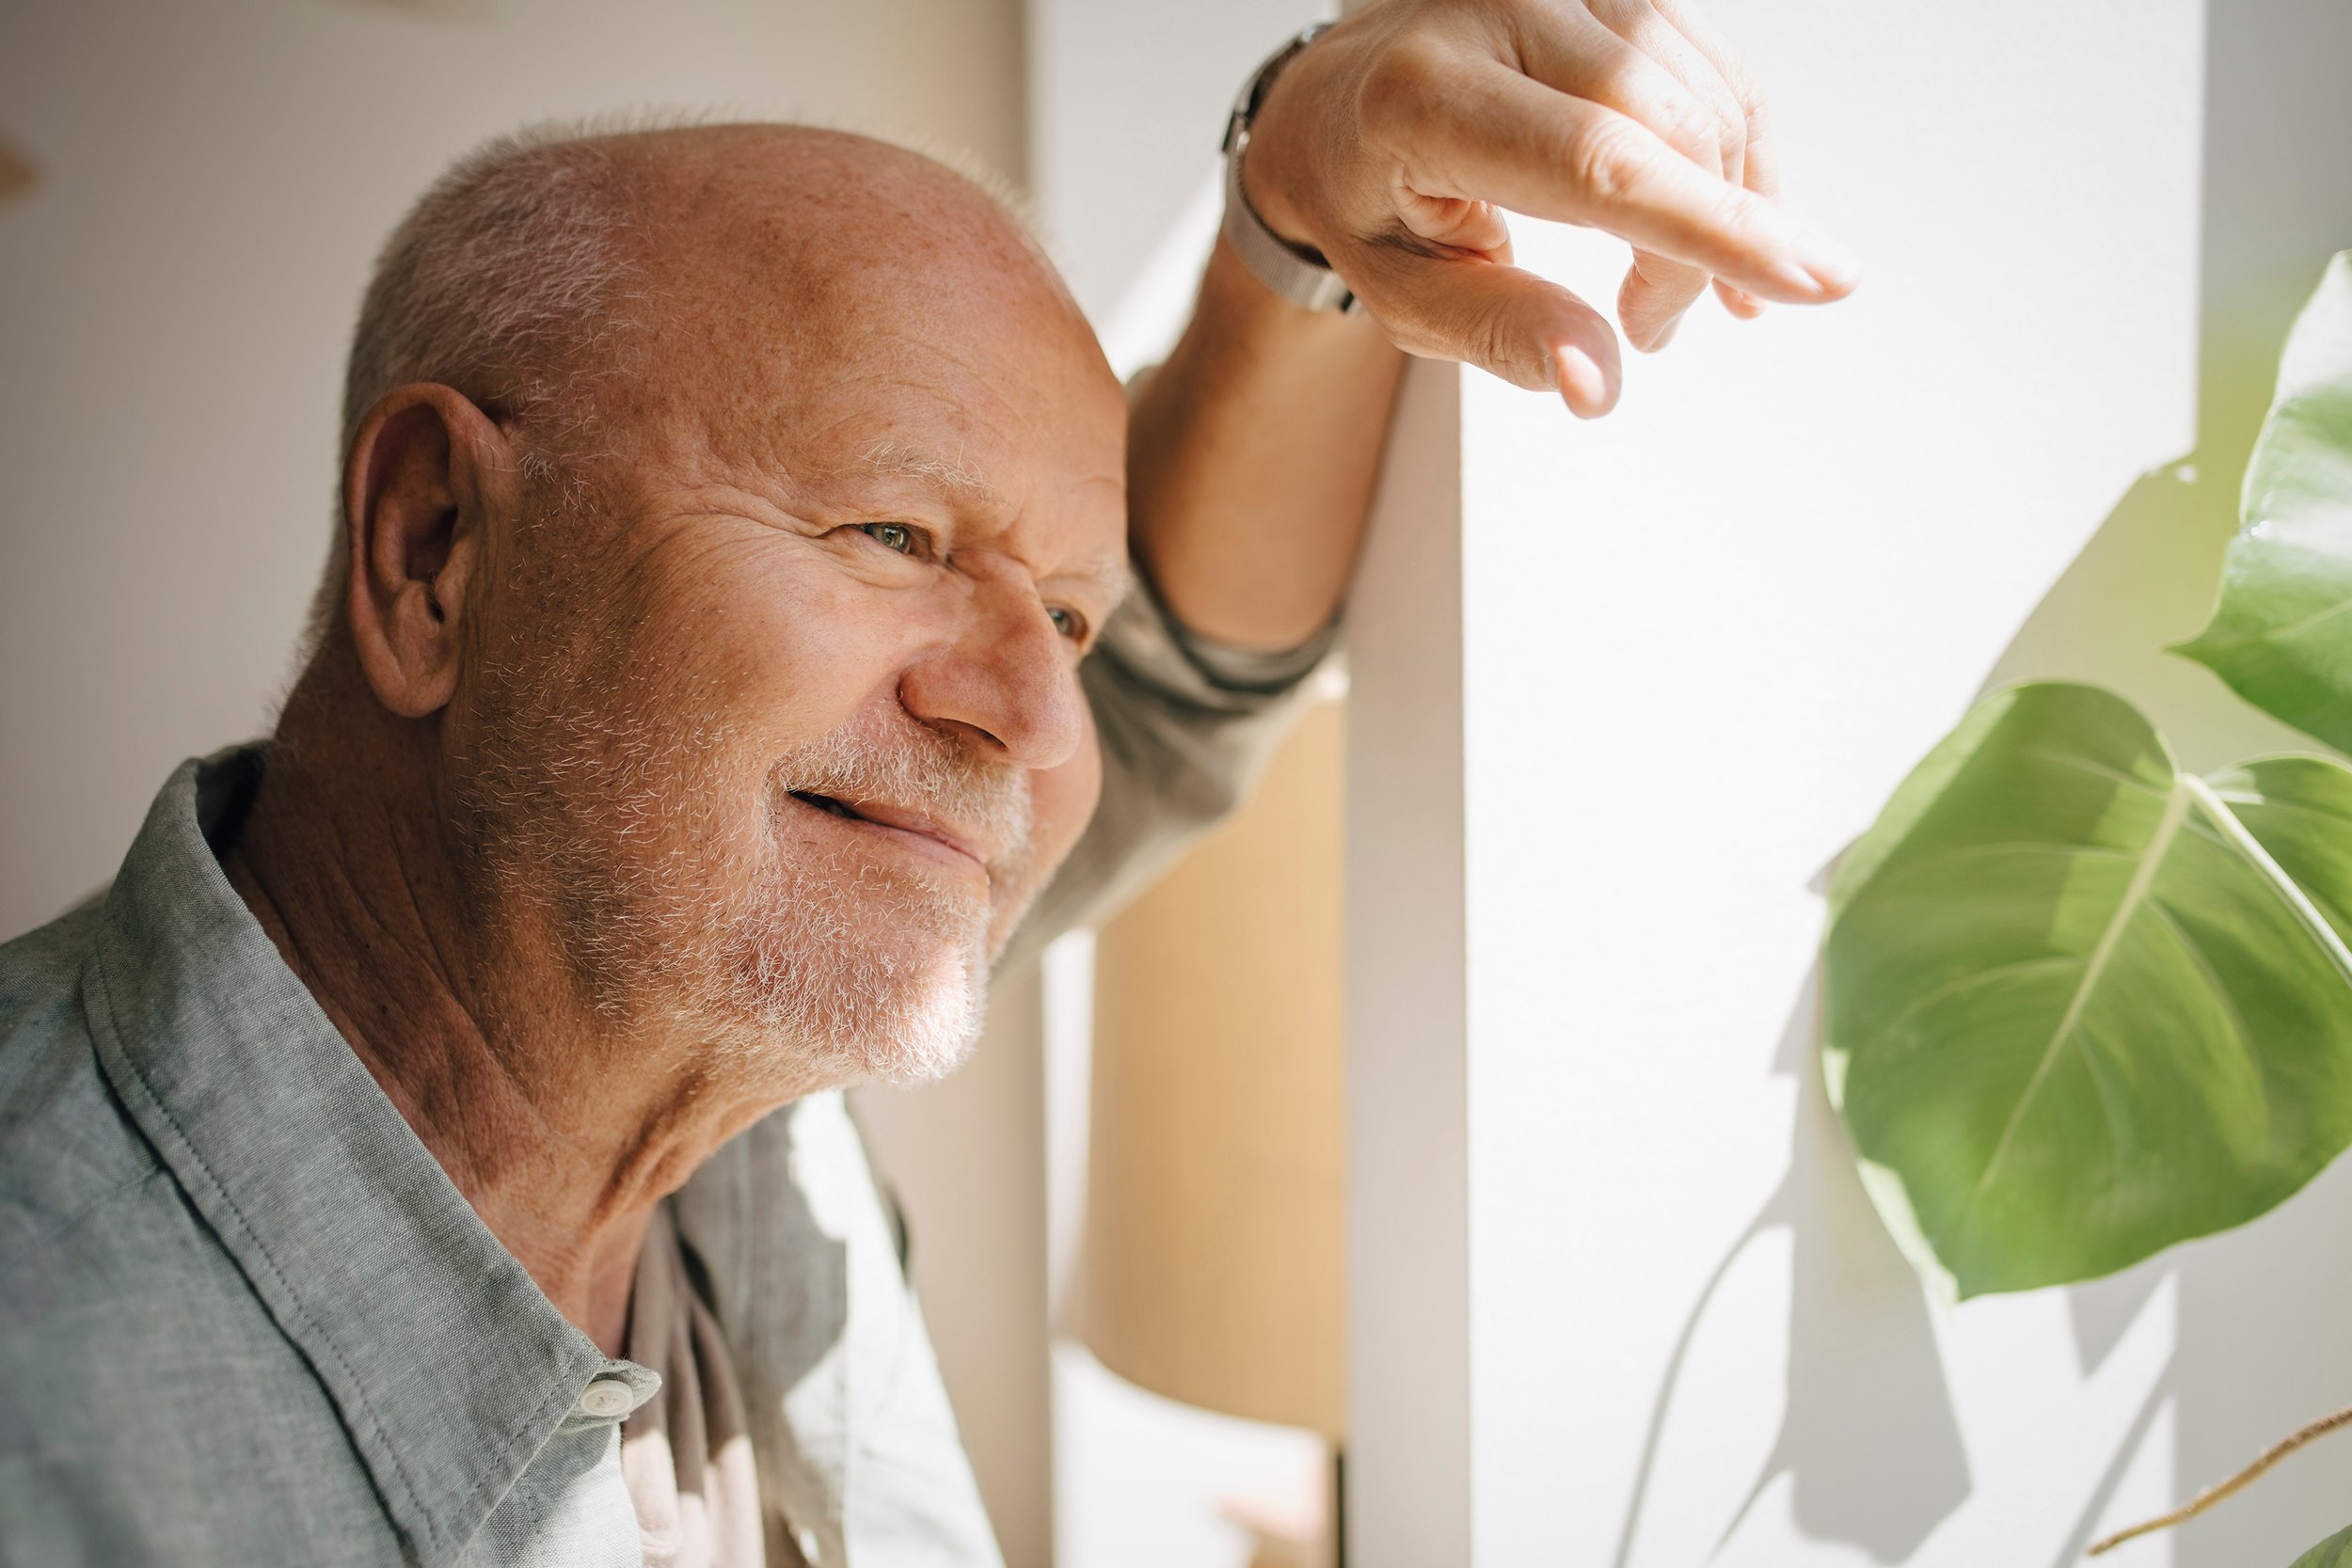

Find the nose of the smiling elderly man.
[{"left": 898, "top": 574, "right": 1087, "bottom": 768}]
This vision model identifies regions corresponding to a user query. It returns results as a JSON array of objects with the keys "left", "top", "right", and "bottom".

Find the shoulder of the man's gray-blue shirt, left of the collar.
[{"left": 0, "top": 905, "right": 398, "bottom": 1568}]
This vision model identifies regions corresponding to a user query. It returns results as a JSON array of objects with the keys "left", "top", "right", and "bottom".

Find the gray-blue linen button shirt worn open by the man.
[{"left": 0, "top": 593, "right": 1322, "bottom": 1568}]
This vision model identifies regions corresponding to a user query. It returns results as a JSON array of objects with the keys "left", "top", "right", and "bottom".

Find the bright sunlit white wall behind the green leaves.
[{"left": 1350, "top": 0, "right": 2352, "bottom": 1568}]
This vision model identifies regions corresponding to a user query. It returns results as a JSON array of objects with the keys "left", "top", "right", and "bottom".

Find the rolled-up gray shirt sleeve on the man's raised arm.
[{"left": 997, "top": 569, "right": 1339, "bottom": 975}]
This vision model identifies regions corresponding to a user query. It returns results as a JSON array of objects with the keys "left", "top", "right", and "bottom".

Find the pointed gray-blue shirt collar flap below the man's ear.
[{"left": 83, "top": 745, "right": 612, "bottom": 1568}]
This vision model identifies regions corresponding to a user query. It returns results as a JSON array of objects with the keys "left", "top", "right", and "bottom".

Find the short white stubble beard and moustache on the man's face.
[{"left": 461, "top": 672, "right": 1030, "bottom": 1093}]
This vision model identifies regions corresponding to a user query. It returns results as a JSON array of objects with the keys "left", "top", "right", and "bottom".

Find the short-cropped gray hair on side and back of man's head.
[{"left": 309, "top": 122, "right": 652, "bottom": 649}]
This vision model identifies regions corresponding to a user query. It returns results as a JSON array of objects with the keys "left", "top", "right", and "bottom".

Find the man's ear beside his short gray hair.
[{"left": 343, "top": 383, "right": 516, "bottom": 720}]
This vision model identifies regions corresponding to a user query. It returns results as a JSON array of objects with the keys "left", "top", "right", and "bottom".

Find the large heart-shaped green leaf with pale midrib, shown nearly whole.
[{"left": 1823, "top": 684, "right": 2352, "bottom": 1295}]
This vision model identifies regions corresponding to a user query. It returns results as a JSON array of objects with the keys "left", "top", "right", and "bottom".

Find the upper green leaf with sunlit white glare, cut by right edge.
[{"left": 2173, "top": 251, "right": 2352, "bottom": 750}]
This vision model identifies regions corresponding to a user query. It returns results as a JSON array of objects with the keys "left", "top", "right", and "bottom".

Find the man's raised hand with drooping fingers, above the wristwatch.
[{"left": 1242, "top": 0, "right": 1858, "bottom": 419}]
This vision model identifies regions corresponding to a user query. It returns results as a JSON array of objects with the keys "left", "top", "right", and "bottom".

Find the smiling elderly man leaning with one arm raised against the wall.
[{"left": 0, "top": 0, "right": 1851, "bottom": 1568}]
